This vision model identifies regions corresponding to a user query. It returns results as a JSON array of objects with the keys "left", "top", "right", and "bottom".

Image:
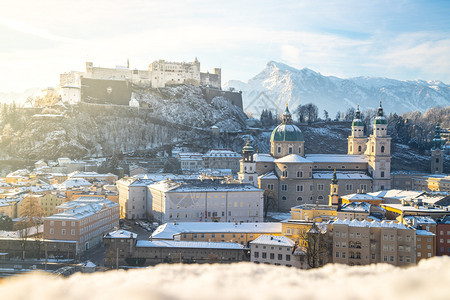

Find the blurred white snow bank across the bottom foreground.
[{"left": 0, "top": 257, "right": 450, "bottom": 300}]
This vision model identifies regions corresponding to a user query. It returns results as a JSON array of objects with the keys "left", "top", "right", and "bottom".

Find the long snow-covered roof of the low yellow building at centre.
[{"left": 152, "top": 222, "right": 281, "bottom": 240}]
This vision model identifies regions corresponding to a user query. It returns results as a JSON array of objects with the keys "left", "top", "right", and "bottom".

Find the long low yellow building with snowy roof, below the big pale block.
[{"left": 151, "top": 222, "right": 281, "bottom": 246}]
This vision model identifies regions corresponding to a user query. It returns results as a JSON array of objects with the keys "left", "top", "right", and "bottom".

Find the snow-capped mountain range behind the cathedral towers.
[{"left": 226, "top": 61, "right": 450, "bottom": 118}]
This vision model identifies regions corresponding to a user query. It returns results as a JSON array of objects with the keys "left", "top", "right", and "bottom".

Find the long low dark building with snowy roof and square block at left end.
[{"left": 104, "top": 230, "right": 249, "bottom": 267}]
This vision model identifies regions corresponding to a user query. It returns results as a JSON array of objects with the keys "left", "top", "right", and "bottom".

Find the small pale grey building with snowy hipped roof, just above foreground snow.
[{"left": 250, "top": 235, "right": 308, "bottom": 269}]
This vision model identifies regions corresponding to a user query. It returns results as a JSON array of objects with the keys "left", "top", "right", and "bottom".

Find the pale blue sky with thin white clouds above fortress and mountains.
[{"left": 0, "top": 0, "right": 450, "bottom": 92}]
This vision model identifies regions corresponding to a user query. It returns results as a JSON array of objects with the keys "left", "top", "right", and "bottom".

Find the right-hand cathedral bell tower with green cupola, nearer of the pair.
[{"left": 364, "top": 101, "right": 391, "bottom": 191}]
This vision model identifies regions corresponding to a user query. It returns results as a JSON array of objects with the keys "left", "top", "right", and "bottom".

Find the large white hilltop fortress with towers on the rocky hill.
[{"left": 60, "top": 58, "right": 232, "bottom": 107}]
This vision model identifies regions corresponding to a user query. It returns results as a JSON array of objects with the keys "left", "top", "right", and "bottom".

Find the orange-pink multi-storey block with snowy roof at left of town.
[{"left": 44, "top": 197, "right": 119, "bottom": 252}]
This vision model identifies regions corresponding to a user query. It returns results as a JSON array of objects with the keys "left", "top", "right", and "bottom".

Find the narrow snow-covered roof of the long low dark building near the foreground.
[{"left": 136, "top": 240, "right": 244, "bottom": 250}]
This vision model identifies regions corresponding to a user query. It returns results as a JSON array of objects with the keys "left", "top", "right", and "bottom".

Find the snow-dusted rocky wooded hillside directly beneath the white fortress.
[{"left": 0, "top": 86, "right": 245, "bottom": 159}]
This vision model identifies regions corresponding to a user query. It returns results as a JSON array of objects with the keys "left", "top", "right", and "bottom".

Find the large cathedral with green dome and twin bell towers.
[{"left": 238, "top": 102, "right": 391, "bottom": 211}]
